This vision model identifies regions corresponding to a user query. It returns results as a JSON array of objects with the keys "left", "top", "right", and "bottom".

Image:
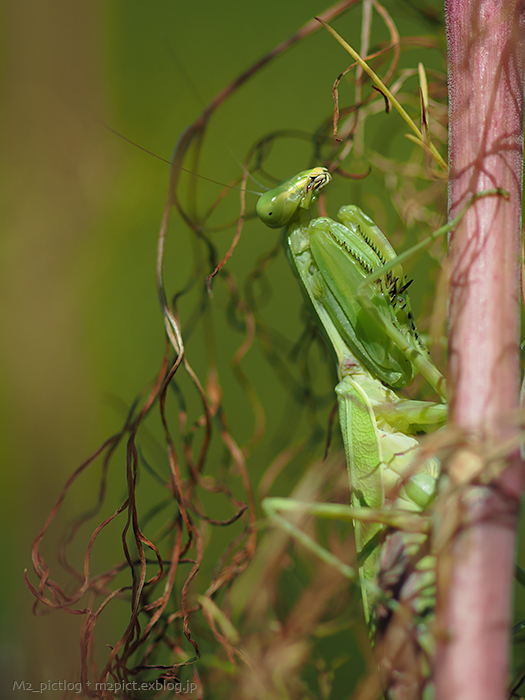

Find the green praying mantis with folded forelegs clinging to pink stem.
[{"left": 257, "top": 167, "right": 504, "bottom": 699}]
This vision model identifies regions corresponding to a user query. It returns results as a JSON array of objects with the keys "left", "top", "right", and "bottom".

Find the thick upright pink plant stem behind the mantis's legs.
[{"left": 435, "top": 0, "right": 525, "bottom": 700}]
